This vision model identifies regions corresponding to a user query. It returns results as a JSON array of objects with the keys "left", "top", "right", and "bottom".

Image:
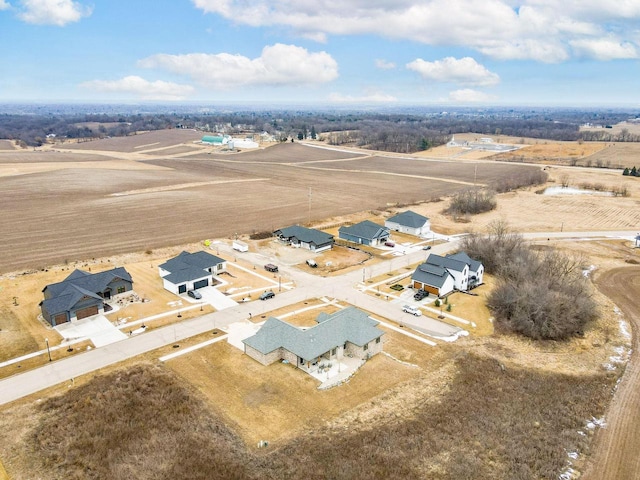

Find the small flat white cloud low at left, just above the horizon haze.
[{"left": 80, "top": 75, "right": 194, "bottom": 100}]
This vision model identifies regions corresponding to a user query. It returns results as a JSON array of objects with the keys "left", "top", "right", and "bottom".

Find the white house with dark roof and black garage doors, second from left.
[{"left": 158, "top": 251, "right": 227, "bottom": 295}]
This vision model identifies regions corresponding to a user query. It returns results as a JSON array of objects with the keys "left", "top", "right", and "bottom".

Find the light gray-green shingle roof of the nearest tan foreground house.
[{"left": 243, "top": 307, "right": 384, "bottom": 360}]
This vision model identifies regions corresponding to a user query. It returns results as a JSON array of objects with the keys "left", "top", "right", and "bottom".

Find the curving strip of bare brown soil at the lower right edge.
[{"left": 583, "top": 267, "right": 640, "bottom": 480}]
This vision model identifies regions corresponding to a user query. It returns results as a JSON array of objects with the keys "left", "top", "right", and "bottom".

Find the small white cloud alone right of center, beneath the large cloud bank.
[{"left": 407, "top": 57, "right": 500, "bottom": 87}]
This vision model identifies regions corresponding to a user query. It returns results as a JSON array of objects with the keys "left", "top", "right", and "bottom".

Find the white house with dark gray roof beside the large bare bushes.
[{"left": 411, "top": 252, "right": 484, "bottom": 297}]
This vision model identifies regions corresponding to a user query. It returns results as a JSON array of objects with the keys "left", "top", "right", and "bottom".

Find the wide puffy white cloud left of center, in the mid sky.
[{"left": 138, "top": 43, "right": 338, "bottom": 89}]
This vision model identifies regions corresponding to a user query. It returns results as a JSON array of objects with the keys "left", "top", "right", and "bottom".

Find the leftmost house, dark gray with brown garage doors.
[{"left": 40, "top": 267, "right": 133, "bottom": 327}]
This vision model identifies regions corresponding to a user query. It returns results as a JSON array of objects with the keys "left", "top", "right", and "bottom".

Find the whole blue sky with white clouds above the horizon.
[{"left": 0, "top": 0, "right": 640, "bottom": 108}]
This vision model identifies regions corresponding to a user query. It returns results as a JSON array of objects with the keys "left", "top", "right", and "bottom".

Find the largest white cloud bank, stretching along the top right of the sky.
[{"left": 192, "top": 0, "right": 640, "bottom": 63}]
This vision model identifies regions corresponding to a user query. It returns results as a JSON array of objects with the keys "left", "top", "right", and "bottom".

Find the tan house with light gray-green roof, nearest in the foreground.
[{"left": 243, "top": 307, "right": 384, "bottom": 372}]
